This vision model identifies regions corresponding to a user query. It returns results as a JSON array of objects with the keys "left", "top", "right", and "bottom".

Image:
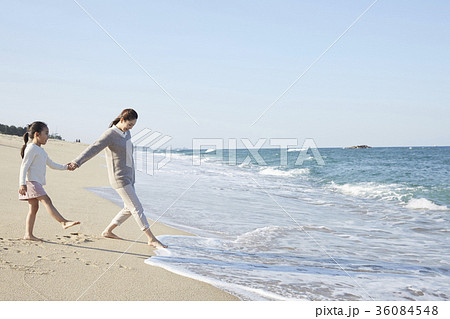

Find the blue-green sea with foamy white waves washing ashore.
[{"left": 89, "top": 147, "right": 450, "bottom": 300}]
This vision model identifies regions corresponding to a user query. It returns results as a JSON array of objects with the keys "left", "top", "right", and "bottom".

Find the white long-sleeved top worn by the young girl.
[{"left": 19, "top": 143, "right": 67, "bottom": 186}]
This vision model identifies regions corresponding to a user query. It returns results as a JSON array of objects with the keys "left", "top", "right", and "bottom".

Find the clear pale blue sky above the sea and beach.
[{"left": 0, "top": 0, "right": 450, "bottom": 147}]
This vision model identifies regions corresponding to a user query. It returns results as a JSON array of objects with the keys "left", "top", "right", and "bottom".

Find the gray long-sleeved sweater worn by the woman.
[{"left": 72, "top": 126, "right": 135, "bottom": 189}]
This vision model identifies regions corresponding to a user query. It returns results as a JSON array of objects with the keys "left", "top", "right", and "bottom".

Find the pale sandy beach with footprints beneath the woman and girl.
[{"left": 0, "top": 135, "right": 238, "bottom": 301}]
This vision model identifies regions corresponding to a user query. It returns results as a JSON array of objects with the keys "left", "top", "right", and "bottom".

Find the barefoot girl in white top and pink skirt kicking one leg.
[{"left": 19, "top": 122, "right": 80, "bottom": 241}]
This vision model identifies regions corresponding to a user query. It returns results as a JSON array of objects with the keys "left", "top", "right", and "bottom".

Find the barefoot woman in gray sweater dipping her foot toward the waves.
[{"left": 69, "top": 109, "right": 167, "bottom": 248}]
